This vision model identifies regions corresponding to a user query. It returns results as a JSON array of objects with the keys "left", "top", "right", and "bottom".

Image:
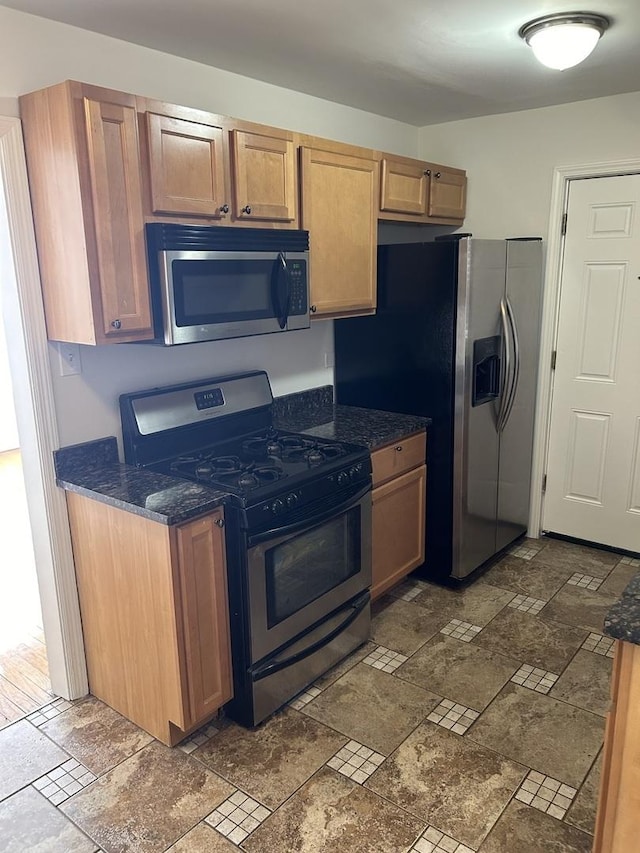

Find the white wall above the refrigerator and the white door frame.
[{"left": 420, "top": 92, "right": 640, "bottom": 239}]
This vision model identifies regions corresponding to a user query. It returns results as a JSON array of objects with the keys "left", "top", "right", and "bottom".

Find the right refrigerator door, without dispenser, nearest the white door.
[{"left": 496, "top": 240, "right": 542, "bottom": 551}]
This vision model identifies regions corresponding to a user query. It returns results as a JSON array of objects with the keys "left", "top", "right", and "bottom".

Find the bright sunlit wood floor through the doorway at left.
[{"left": 0, "top": 450, "right": 54, "bottom": 728}]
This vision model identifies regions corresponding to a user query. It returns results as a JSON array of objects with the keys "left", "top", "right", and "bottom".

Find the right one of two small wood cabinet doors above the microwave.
[{"left": 231, "top": 130, "right": 297, "bottom": 222}]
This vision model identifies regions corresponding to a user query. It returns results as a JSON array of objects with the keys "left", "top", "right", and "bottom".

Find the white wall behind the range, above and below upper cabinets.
[{"left": 0, "top": 6, "right": 419, "bottom": 452}]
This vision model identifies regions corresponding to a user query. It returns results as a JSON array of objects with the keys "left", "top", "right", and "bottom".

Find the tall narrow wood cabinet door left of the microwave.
[{"left": 84, "top": 98, "right": 152, "bottom": 340}]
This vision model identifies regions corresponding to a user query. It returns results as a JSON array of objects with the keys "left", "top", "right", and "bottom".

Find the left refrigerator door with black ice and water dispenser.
[{"left": 451, "top": 239, "right": 506, "bottom": 578}]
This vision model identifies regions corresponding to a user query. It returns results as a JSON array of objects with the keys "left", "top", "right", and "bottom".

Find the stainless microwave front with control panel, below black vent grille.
[{"left": 160, "top": 250, "right": 309, "bottom": 344}]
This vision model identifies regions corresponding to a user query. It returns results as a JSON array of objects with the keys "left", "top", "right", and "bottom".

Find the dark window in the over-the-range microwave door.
[{"left": 172, "top": 258, "right": 274, "bottom": 326}]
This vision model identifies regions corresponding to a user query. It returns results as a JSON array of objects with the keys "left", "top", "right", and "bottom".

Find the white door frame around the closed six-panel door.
[{"left": 527, "top": 159, "right": 640, "bottom": 539}]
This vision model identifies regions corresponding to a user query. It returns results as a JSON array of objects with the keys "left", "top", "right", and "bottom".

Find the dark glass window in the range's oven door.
[{"left": 265, "top": 506, "right": 361, "bottom": 628}]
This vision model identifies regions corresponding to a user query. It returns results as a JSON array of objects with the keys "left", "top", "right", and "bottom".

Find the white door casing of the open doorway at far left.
[{"left": 0, "top": 116, "right": 88, "bottom": 699}]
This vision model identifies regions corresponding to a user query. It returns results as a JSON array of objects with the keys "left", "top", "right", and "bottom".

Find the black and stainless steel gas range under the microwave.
[{"left": 120, "top": 371, "right": 371, "bottom": 726}]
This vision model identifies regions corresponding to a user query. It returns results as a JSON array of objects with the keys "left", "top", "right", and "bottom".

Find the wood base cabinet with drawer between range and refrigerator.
[{"left": 371, "top": 432, "right": 427, "bottom": 599}]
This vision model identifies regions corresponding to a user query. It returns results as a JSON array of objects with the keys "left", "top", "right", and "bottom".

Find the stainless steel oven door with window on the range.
[{"left": 247, "top": 485, "right": 371, "bottom": 664}]
